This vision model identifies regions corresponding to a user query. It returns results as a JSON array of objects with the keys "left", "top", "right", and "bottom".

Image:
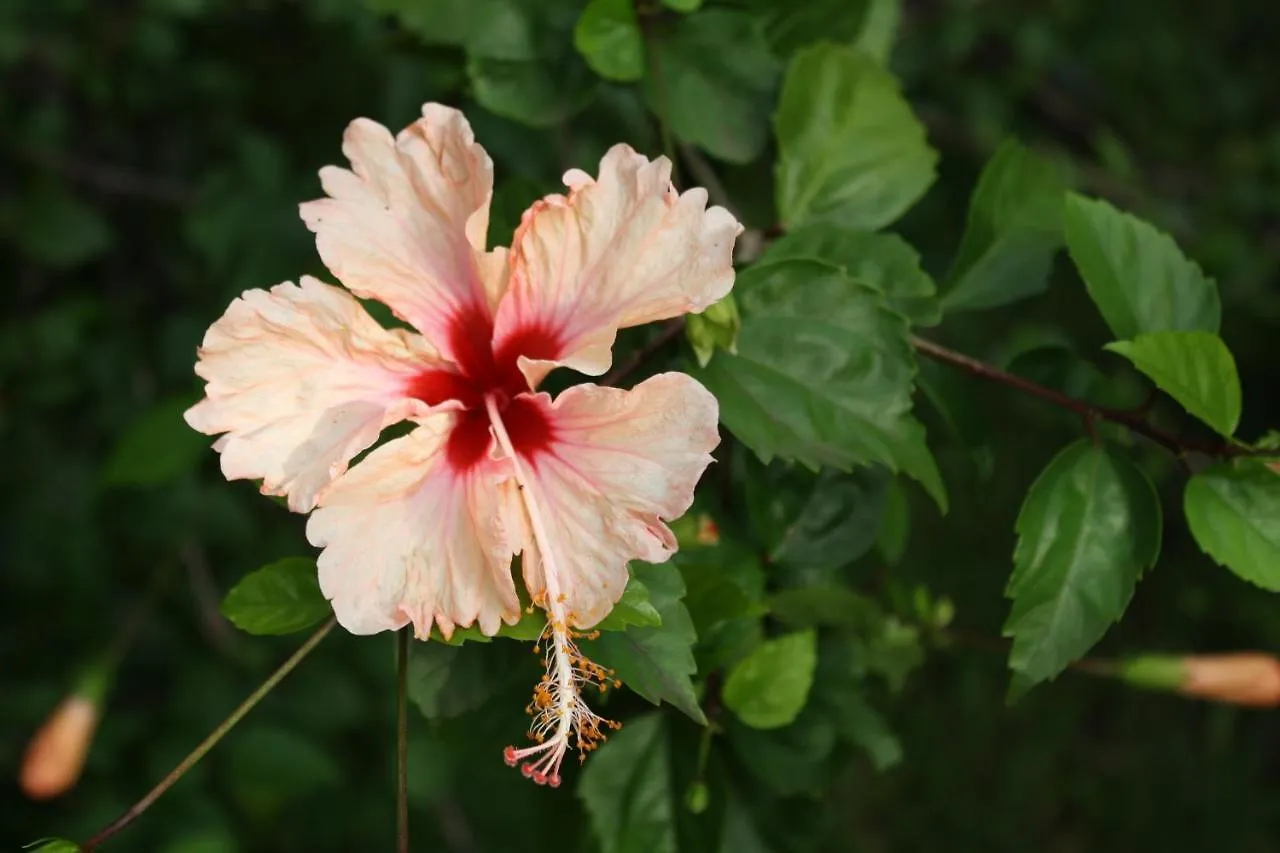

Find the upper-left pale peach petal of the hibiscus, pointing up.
[{"left": 300, "top": 104, "right": 506, "bottom": 350}]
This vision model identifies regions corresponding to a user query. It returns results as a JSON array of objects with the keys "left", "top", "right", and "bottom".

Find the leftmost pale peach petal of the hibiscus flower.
[{"left": 187, "top": 277, "right": 443, "bottom": 512}]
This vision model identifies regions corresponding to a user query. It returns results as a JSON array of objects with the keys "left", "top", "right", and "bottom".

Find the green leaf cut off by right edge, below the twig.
[{"left": 1183, "top": 461, "right": 1280, "bottom": 592}]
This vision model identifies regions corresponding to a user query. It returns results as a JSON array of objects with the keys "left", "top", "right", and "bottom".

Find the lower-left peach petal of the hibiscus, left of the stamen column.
[{"left": 307, "top": 412, "right": 524, "bottom": 639}]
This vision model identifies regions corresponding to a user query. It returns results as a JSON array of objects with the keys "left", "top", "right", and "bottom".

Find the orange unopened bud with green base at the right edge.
[{"left": 1120, "top": 652, "right": 1280, "bottom": 707}]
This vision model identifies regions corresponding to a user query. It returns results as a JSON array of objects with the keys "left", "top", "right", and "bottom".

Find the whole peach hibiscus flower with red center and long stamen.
[{"left": 187, "top": 104, "right": 742, "bottom": 785}]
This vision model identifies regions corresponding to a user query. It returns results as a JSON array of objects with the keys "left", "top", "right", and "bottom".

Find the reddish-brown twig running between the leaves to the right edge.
[{"left": 911, "top": 337, "right": 1259, "bottom": 457}]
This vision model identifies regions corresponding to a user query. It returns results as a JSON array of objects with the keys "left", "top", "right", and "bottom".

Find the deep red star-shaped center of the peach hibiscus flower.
[{"left": 406, "top": 305, "right": 561, "bottom": 471}]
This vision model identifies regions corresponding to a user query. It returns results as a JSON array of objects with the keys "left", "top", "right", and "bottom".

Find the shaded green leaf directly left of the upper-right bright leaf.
[{"left": 942, "top": 140, "right": 1066, "bottom": 311}]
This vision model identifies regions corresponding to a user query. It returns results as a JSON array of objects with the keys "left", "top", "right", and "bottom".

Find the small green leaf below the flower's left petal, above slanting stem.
[{"left": 223, "top": 557, "right": 333, "bottom": 635}]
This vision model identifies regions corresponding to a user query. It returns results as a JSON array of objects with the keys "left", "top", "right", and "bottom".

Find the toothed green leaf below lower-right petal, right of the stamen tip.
[{"left": 582, "top": 562, "right": 707, "bottom": 725}]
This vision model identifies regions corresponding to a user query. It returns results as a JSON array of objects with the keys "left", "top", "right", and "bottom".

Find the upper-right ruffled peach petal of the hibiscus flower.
[{"left": 495, "top": 145, "right": 742, "bottom": 384}]
